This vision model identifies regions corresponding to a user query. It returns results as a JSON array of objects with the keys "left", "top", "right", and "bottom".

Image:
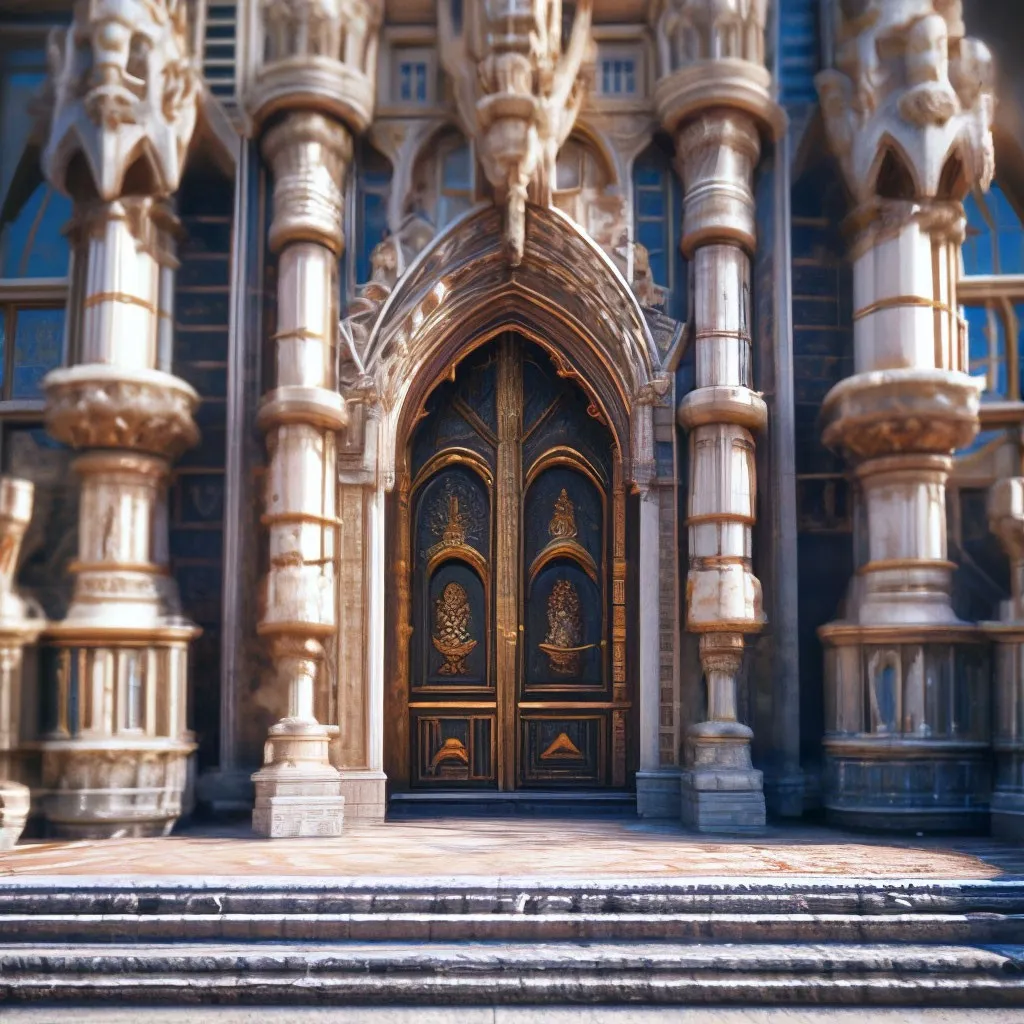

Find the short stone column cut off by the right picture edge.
[{"left": 982, "top": 476, "right": 1024, "bottom": 840}]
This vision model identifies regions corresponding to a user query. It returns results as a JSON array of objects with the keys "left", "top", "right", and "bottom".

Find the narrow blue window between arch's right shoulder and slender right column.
[{"left": 633, "top": 137, "right": 686, "bottom": 319}]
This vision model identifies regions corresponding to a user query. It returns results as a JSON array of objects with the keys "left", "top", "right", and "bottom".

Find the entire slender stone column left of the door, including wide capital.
[{"left": 250, "top": 0, "right": 381, "bottom": 838}]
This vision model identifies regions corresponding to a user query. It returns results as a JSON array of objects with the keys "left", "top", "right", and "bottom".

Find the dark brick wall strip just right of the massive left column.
[{"left": 170, "top": 173, "right": 233, "bottom": 769}]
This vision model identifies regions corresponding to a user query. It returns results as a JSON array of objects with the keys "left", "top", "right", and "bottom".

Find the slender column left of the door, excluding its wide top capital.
[{"left": 253, "top": 112, "right": 351, "bottom": 837}]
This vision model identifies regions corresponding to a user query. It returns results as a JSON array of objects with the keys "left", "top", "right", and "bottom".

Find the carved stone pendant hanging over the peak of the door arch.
[{"left": 438, "top": 0, "right": 593, "bottom": 265}]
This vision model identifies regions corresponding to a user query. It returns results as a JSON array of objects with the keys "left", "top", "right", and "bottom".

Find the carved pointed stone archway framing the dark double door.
[{"left": 338, "top": 206, "right": 669, "bottom": 816}]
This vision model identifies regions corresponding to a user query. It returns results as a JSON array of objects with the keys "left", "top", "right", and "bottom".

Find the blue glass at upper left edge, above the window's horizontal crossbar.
[{"left": 0, "top": 49, "right": 71, "bottom": 278}]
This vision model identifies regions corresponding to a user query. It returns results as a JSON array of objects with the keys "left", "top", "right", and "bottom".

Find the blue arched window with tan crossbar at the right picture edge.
[{"left": 958, "top": 182, "right": 1024, "bottom": 401}]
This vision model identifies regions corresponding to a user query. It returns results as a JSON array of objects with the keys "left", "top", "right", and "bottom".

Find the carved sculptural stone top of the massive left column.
[{"left": 42, "top": 0, "right": 199, "bottom": 202}]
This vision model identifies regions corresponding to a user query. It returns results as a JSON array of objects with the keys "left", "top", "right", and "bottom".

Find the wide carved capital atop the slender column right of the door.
[{"left": 650, "top": 0, "right": 786, "bottom": 144}]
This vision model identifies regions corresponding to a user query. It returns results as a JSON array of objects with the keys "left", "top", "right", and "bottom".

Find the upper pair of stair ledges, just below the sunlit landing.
[{"left": 0, "top": 877, "right": 1024, "bottom": 944}]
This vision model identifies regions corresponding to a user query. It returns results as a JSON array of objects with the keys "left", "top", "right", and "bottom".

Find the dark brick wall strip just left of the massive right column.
[{"left": 792, "top": 162, "right": 853, "bottom": 771}]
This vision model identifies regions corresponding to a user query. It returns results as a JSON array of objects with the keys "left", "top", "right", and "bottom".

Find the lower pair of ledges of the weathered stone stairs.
[{"left": 0, "top": 942, "right": 1024, "bottom": 1008}]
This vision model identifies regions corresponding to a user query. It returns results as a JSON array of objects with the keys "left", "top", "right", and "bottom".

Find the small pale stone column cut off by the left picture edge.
[{"left": 0, "top": 476, "right": 46, "bottom": 850}]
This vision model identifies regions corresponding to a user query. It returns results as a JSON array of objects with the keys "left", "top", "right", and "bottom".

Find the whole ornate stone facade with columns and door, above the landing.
[{"left": 0, "top": 0, "right": 1024, "bottom": 837}]
